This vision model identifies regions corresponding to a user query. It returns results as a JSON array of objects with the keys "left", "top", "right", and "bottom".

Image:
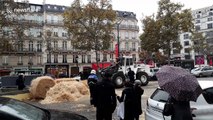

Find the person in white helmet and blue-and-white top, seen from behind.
[{"left": 87, "top": 70, "right": 98, "bottom": 105}]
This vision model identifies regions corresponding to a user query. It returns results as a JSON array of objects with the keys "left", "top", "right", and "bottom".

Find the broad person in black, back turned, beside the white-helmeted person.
[{"left": 94, "top": 72, "right": 117, "bottom": 120}]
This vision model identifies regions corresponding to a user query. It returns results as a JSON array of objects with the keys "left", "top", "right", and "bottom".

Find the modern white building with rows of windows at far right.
[{"left": 172, "top": 6, "right": 213, "bottom": 64}]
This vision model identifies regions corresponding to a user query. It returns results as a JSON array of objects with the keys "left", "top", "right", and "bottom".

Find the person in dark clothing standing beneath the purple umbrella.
[{"left": 169, "top": 97, "right": 193, "bottom": 120}]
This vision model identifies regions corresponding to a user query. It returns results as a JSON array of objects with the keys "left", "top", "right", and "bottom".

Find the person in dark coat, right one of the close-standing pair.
[{"left": 134, "top": 80, "right": 144, "bottom": 120}]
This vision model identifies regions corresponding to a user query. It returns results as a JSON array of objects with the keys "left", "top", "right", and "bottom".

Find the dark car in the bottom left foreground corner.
[{"left": 0, "top": 97, "right": 88, "bottom": 120}]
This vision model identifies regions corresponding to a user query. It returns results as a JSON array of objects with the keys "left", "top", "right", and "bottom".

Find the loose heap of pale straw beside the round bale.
[{"left": 41, "top": 81, "right": 89, "bottom": 104}]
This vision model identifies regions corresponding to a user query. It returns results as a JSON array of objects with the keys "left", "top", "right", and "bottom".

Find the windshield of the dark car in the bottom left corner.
[{"left": 0, "top": 100, "right": 45, "bottom": 120}]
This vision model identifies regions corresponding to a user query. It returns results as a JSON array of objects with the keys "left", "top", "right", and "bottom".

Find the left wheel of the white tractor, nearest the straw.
[{"left": 112, "top": 72, "right": 125, "bottom": 88}]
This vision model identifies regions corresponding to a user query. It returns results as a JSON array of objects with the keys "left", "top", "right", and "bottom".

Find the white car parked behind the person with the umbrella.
[{"left": 145, "top": 81, "right": 213, "bottom": 120}]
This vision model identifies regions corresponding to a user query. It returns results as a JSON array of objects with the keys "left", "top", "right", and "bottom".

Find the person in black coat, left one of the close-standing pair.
[{"left": 117, "top": 81, "right": 136, "bottom": 120}]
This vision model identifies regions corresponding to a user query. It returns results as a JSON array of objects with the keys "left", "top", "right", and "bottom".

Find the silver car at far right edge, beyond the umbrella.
[{"left": 191, "top": 66, "right": 213, "bottom": 77}]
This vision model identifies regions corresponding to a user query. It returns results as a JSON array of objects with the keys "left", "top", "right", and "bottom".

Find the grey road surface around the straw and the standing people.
[{"left": 28, "top": 77, "right": 213, "bottom": 120}]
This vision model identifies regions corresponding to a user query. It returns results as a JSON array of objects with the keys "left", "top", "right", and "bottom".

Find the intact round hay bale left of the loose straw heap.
[{"left": 29, "top": 76, "right": 55, "bottom": 99}]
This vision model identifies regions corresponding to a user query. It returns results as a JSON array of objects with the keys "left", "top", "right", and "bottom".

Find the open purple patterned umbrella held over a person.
[{"left": 156, "top": 66, "right": 202, "bottom": 101}]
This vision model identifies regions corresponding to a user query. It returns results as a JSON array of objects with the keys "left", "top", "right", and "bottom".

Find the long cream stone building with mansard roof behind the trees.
[{"left": 0, "top": 4, "right": 140, "bottom": 76}]
